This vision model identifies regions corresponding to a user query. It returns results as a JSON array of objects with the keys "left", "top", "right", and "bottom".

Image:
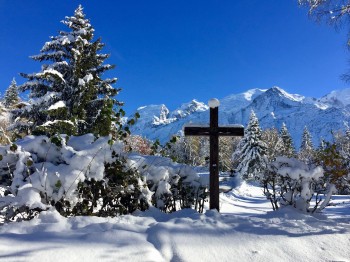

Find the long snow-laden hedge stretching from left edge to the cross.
[{"left": 0, "top": 134, "right": 205, "bottom": 221}]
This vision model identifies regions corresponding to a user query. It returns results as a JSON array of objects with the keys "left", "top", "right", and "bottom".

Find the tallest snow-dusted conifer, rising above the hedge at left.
[{"left": 14, "top": 5, "right": 121, "bottom": 136}]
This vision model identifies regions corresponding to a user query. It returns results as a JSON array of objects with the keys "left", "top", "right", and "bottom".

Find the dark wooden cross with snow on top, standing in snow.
[{"left": 184, "top": 98, "right": 244, "bottom": 211}]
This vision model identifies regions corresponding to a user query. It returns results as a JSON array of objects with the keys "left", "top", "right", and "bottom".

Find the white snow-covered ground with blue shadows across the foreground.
[{"left": 0, "top": 179, "right": 350, "bottom": 262}]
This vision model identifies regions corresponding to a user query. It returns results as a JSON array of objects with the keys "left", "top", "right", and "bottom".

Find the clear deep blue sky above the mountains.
[{"left": 0, "top": 0, "right": 350, "bottom": 114}]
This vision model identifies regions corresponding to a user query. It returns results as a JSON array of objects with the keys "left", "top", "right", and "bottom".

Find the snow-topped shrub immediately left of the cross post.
[{"left": 128, "top": 154, "right": 208, "bottom": 212}]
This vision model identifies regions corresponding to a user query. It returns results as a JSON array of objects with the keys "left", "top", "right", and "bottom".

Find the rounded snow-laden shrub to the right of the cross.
[{"left": 261, "top": 157, "right": 334, "bottom": 212}]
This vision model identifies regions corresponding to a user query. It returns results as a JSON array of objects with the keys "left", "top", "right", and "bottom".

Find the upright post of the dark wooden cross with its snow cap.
[{"left": 208, "top": 99, "right": 220, "bottom": 211}]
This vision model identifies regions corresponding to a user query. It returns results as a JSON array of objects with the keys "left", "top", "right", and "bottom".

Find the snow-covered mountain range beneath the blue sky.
[{"left": 132, "top": 87, "right": 350, "bottom": 148}]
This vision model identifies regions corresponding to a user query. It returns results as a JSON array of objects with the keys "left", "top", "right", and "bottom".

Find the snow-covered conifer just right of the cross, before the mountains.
[{"left": 233, "top": 110, "right": 267, "bottom": 180}]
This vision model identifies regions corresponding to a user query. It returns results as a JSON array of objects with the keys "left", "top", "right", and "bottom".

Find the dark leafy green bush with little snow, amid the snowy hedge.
[{"left": 62, "top": 152, "right": 152, "bottom": 217}]
